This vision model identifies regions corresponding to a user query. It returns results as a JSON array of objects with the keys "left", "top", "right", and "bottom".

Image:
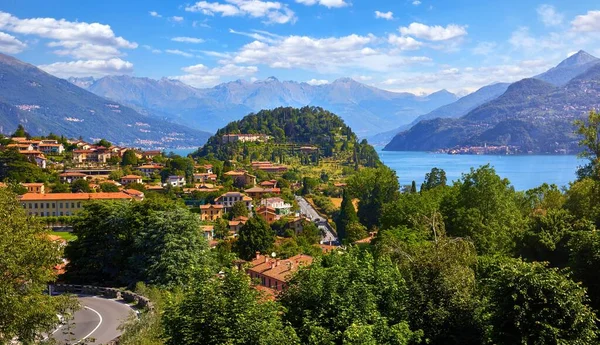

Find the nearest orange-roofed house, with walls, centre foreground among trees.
[{"left": 240, "top": 253, "right": 313, "bottom": 291}]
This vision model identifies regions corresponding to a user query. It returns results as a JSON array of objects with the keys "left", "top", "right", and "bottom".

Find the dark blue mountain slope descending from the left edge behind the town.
[{"left": 0, "top": 54, "right": 209, "bottom": 147}]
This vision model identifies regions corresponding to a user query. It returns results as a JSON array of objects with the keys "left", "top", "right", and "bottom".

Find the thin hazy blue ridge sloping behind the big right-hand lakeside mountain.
[{"left": 368, "top": 83, "right": 509, "bottom": 145}]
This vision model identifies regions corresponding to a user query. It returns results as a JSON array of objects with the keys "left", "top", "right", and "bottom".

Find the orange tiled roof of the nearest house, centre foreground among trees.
[{"left": 248, "top": 254, "right": 313, "bottom": 282}]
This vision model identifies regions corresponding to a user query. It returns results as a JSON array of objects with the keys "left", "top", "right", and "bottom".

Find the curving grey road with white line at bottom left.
[{"left": 52, "top": 297, "right": 133, "bottom": 344}]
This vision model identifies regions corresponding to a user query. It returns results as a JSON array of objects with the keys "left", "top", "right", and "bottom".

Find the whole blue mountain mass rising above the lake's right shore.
[{"left": 385, "top": 51, "right": 600, "bottom": 153}]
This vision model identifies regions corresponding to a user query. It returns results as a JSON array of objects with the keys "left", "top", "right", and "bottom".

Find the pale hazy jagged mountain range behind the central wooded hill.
[{"left": 77, "top": 76, "right": 457, "bottom": 136}]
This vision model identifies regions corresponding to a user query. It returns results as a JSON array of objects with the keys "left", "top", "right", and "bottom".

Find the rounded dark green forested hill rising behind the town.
[{"left": 194, "top": 107, "right": 380, "bottom": 166}]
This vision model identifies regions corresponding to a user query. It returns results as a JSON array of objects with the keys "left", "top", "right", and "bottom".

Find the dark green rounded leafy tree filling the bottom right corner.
[{"left": 479, "top": 259, "right": 598, "bottom": 345}]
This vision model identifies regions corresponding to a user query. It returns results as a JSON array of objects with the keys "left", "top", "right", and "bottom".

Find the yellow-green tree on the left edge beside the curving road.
[{"left": 0, "top": 189, "right": 76, "bottom": 344}]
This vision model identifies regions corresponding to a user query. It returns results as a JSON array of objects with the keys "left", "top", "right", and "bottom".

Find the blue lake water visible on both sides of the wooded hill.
[{"left": 167, "top": 147, "right": 585, "bottom": 190}]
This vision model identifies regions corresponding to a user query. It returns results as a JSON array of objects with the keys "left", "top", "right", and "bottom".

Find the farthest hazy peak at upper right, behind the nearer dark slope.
[{"left": 534, "top": 50, "right": 600, "bottom": 86}]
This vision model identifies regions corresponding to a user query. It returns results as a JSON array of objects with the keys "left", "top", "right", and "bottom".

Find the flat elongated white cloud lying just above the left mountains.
[{"left": 38, "top": 59, "right": 133, "bottom": 78}]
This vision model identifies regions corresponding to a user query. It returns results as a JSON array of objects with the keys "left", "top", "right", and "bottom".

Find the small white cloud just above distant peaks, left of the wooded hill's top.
[{"left": 170, "top": 64, "right": 258, "bottom": 87}]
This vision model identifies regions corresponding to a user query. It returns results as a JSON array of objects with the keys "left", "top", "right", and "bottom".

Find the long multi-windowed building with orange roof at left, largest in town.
[{"left": 19, "top": 192, "right": 132, "bottom": 217}]
